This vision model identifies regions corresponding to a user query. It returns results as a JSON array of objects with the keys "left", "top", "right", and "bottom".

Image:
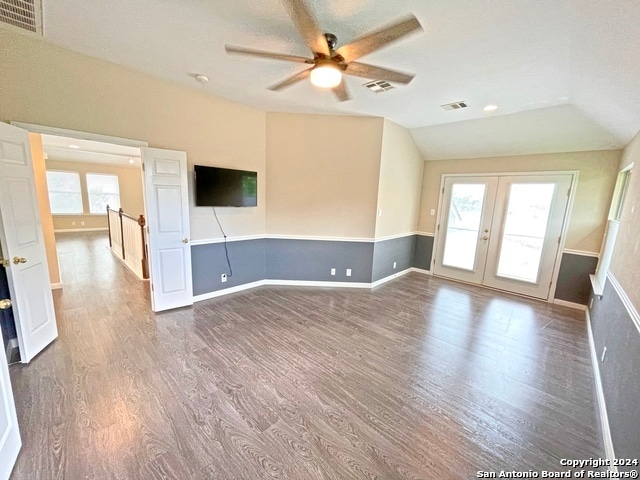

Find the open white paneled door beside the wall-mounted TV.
[{"left": 140, "top": 147, "right": 193, "bottom": 312}]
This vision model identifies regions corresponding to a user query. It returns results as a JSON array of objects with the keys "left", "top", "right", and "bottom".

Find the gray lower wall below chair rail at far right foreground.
[{"left": 589, "top": 280, "right": 640, "bottom": 471}]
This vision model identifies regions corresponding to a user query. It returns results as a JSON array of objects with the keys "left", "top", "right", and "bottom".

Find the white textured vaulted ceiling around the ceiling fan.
[{"left": 38, "top": 0, "right": 640, "bottom": 159}]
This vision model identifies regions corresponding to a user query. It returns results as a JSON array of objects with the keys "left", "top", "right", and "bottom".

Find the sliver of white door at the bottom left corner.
[{"left": 0, "top": 318, "right": 22, "bottom": 480}]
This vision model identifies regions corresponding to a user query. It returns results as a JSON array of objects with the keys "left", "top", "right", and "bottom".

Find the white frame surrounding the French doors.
[{"left": 431, "top": 170, "right": 580, "bottom": 303}]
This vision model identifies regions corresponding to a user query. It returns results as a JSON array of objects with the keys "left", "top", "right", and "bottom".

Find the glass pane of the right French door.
[{"left": 497, "top": 183, "right": 555, "bottom": 283}]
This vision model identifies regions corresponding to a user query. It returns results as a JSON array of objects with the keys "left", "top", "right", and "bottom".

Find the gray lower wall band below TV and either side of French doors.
[{"left": 191, "top": 235, "right": 598, "bottom": 305}]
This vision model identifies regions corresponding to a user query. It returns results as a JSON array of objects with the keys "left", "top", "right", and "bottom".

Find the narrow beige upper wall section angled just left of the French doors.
[{"left": 375, "top": 120, "right": 424, "bottom": 238}]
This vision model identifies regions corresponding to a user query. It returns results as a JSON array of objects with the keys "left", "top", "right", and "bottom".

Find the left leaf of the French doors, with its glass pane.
[{"left": 433, "top": 177, "right": 498, "bottom": 283}]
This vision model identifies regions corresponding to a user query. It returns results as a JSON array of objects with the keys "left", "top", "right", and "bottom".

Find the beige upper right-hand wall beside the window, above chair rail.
[{"left": 609, "top": 132, "right": 640, "bottom": 311}]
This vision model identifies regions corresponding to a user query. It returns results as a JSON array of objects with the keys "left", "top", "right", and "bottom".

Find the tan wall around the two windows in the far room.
[{"left": 46, "top": 160, "right": 144, "bottom": 230}]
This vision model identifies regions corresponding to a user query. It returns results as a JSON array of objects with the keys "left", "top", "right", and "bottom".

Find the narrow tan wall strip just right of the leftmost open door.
[{"left": 29, "top": 133, "right": 60, "bottom": 286}]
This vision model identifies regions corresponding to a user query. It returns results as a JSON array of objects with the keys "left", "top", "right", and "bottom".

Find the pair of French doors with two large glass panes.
[{"left": 433, "top": 174, "right": 573, "bottom": 299}]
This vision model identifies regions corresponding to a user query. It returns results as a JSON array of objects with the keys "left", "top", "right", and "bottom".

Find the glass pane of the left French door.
[{"left": 442, "top": 183, "right": 487, "bottom": 270}]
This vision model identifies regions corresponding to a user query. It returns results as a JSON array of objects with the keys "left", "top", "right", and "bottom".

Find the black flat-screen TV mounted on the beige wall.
[{"left": 194, "top": 165, "right": 258, "bottom": 207}]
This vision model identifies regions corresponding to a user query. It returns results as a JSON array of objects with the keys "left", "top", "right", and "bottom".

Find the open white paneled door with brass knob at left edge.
[{"left": 0, "top": 122, "right": 58, "bottom": 363}]
